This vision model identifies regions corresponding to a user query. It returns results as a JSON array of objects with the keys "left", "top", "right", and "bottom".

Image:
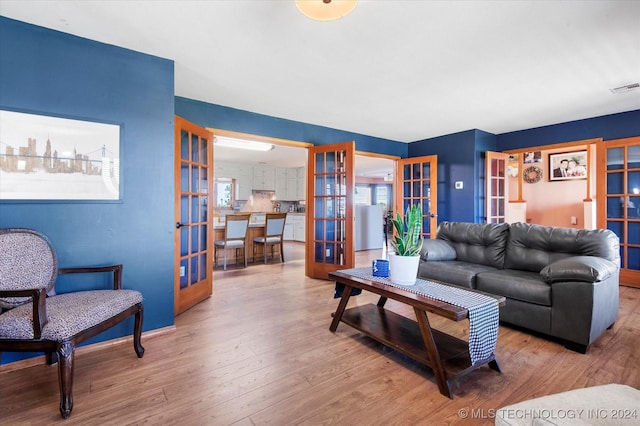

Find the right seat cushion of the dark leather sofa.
[{"left": 476, "top": 269, "right": 551, "bottom": 306}]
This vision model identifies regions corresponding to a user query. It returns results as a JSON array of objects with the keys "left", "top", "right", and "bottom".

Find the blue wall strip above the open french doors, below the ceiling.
[{"left": 176, "top": 96, "right": 407, "bottom": 158}]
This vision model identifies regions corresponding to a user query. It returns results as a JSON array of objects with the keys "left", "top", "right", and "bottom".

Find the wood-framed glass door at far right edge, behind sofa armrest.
[{"left": 597, "top": 137, "right": 640, "bottom": 287}]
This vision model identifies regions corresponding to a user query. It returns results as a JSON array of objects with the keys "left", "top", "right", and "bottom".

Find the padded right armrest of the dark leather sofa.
[{"left": 540, "top": 256, "right": 618, "bottom": 283}]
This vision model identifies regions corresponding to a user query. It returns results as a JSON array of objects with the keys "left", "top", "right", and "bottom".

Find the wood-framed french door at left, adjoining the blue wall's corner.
[{"left": 173, "top": 116, "right": 213, "bottom": 315}]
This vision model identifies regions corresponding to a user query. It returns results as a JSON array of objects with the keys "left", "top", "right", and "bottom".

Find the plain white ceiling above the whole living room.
[{"left": 0, "top": 0, "right": 640, "bottom": 166}]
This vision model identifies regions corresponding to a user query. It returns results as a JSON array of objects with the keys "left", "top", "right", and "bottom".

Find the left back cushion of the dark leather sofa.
[{"left": 436, "top": 222, "right": 509, "bottom": 269}]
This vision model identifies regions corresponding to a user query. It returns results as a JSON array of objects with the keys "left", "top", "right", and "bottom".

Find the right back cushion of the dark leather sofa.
[{"left": 504, "top": 223, "right": 620, "bottom": 272}]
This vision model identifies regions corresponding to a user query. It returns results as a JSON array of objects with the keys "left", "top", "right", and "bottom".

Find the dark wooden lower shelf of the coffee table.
[{"left": 341, "top": 304, "right": 476, "bottom": 378}]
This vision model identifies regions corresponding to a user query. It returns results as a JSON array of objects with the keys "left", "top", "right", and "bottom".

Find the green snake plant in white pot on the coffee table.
[{"left": 389, "top": 204, "right": 424, "bottom": 285}]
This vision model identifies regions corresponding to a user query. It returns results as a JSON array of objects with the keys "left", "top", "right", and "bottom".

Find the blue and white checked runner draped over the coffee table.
[{"left": 339, "top": 268, "right": 499, "bottom": 366}]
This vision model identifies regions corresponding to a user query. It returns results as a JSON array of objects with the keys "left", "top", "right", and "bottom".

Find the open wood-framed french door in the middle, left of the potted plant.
[{"left": 305, "top": 142, "right": 355, "bottom": 279}]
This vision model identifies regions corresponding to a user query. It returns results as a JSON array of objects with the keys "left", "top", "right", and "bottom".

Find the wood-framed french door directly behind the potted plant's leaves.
[{"left": 394, "top": 155, "right": 438, "bottom": 238}]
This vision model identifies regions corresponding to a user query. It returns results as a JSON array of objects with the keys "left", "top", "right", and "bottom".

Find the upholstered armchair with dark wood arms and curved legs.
[{"left": 0, "top": 229, "right": 144, "bottom": 418}]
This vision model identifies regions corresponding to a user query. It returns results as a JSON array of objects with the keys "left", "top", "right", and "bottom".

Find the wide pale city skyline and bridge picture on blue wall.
[{"left": 0, "top": 109, "right": 122, "bottom": 201}]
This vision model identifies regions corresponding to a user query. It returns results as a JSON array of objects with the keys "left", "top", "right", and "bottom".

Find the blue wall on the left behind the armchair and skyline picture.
[{"left": 0, "top": 17, "right": 174, "bottom": 363}]
